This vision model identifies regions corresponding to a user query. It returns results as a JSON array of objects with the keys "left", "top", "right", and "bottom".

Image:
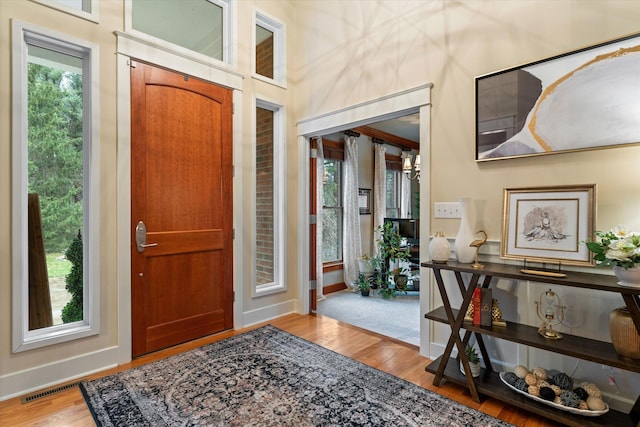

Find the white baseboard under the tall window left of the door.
[{"left": 0, "top": 347, "right": 118, "bottom": 401}]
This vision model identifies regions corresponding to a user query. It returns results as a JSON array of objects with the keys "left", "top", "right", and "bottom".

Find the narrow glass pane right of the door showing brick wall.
[{"left": 256, "top": 107, "right": 274, "bottom": 285}]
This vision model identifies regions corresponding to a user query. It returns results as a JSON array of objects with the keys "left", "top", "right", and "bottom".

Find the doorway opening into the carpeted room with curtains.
[{"left": 310, "top": 113, "right": 420, "bottom": 345}]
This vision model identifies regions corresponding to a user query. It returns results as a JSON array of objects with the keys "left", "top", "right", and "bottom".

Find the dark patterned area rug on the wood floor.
[{"left": 80, "top": 326, "right": 509, "bottom": 427}]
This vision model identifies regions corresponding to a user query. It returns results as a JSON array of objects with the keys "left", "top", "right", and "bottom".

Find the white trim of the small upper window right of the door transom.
[{"left": 251, "top": 9, "right": 287, "bottom": 89}]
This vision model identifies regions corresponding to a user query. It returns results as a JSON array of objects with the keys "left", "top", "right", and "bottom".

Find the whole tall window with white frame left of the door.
[{"left": 13, "top": 24, "right": 98, "bottom": 351}]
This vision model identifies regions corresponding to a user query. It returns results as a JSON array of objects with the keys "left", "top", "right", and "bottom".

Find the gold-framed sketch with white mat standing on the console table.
[{"left": 500, "top": 184, "right": 596, "bottom": 266}]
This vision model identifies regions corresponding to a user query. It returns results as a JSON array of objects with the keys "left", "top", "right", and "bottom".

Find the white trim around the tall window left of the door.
[{"left": 11, "top": 20, "right": 100, "bottom": 352}]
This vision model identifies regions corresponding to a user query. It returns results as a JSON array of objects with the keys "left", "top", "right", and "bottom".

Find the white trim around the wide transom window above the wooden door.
[{"left": 124, "top": 0, "right": 237, "bottom": 68}]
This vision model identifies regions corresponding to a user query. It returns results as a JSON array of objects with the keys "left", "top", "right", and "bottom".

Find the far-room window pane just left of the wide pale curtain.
[{"left": 322, "top": 159, "right": 343, "bottom": 263}]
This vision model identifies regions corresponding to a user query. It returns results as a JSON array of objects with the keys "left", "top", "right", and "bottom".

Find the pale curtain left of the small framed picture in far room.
[{"left": 342, "top": 137, "right": 362, "bottom": 289}]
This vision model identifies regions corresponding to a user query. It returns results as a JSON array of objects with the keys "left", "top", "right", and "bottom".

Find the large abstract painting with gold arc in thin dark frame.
[{"left": 475, "top": 34, "right": 640, "bottom": 161}]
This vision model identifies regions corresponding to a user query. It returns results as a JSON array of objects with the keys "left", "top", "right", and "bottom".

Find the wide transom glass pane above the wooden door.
[{"left": 132, "top": 0, "right": 223, "bottom": 61}]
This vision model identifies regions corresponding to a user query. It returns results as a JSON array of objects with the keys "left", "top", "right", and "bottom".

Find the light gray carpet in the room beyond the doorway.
[{"left": 316, "top": 290, "right": 420, "bottom": 346}]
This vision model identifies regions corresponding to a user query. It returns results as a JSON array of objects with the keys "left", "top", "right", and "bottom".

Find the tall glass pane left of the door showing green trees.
[{"left": 27, "top": 45, "right": 84, "bottom": 330}]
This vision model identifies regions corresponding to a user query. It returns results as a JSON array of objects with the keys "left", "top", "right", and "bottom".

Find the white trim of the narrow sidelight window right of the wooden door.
[{"left": 252, "top": 99, "right": 287, "bottom": 297}]
